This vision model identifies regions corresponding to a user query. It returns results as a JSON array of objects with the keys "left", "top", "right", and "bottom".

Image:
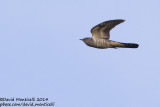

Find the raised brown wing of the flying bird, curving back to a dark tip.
[{"left": 91, "top": 19, "right": 125, "bottom": 39}]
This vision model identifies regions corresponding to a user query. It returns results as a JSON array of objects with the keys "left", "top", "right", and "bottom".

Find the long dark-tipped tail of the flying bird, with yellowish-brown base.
[{"left": 111, "top": 41, "right": 139, "bottom": 48}]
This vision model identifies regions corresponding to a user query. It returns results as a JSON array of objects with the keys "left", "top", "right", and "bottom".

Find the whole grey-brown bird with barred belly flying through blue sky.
[{"left": 80, "top": 19, "right": 139, "bottom": 49}]
